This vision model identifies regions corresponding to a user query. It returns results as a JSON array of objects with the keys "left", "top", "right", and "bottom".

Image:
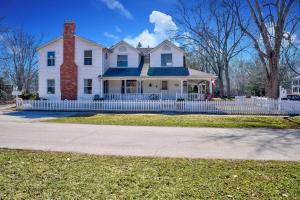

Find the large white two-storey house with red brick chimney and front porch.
[{"left": 38, "top": 22, "right": 217, "bottom": 100}]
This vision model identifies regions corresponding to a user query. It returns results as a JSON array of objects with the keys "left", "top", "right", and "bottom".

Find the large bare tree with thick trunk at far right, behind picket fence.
[{"left": 233, "top": 0, "right": 300, "bottom": 98}]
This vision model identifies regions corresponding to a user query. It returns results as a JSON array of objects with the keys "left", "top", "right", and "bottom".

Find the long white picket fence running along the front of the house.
[{"left": 17, "top": 99, "right": 300, "bottom": 115}]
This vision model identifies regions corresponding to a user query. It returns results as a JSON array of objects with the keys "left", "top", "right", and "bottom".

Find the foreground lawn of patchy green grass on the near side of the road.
[{"left": 0, "top": 149, "right": 300, "bottom": 199}]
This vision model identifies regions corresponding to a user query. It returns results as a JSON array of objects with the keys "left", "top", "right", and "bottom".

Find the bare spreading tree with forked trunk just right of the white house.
[{"left": 174, "top": 0, "right": 246, "bottom": 96}]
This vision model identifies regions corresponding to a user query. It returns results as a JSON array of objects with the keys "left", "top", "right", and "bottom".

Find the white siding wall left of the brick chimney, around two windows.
[{"left": 38, "top": 39, "right": 63, "bottom": 100}]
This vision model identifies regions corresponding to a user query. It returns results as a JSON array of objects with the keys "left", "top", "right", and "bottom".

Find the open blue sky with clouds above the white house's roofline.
[{"left": 0, "top": 0, "right": 176, "bottom": 46}]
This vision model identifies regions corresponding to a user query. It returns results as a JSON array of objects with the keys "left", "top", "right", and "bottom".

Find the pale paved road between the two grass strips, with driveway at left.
[{"left": 0, "top": 112, "right": 300, "bottom": 161}]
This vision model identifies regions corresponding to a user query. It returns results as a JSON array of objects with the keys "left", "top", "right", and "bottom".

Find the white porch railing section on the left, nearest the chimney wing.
[{"left": 103, "top": 93, "right": 162, "bottom": 101}]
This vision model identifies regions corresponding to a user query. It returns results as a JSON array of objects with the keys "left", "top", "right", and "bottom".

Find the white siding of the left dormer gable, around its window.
[{"left": 109, "top": 43, "right": 140, "bottom": 67}]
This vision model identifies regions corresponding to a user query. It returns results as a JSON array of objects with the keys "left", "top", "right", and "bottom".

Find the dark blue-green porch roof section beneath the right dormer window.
[{"left": 147, "top": 67, "right": 189, "bottom": 76}]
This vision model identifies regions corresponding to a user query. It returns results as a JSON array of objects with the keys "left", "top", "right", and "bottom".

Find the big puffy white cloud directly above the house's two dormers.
[{"left": 124, "top": 10, "right": 178, "bottom": 47}]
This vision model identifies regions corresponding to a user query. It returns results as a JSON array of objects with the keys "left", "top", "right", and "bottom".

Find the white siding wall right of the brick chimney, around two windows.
[{"left": 75, "top": 37, "right": 103, "bottom": 100}]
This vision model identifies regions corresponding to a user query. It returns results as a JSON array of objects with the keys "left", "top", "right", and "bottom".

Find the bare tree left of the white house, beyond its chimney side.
[{"left": 1, "top": 31, "right": 40, "bottom": 92}]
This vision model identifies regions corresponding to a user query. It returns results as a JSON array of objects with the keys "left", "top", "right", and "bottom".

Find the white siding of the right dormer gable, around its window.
[{"left": 150, "top": 45, "right": 183, "bottom": 67}]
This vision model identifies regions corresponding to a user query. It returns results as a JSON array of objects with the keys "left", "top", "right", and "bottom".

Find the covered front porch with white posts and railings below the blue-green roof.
[{"left": 100, "top": 78, "right": 212, "bottom": 101}]
